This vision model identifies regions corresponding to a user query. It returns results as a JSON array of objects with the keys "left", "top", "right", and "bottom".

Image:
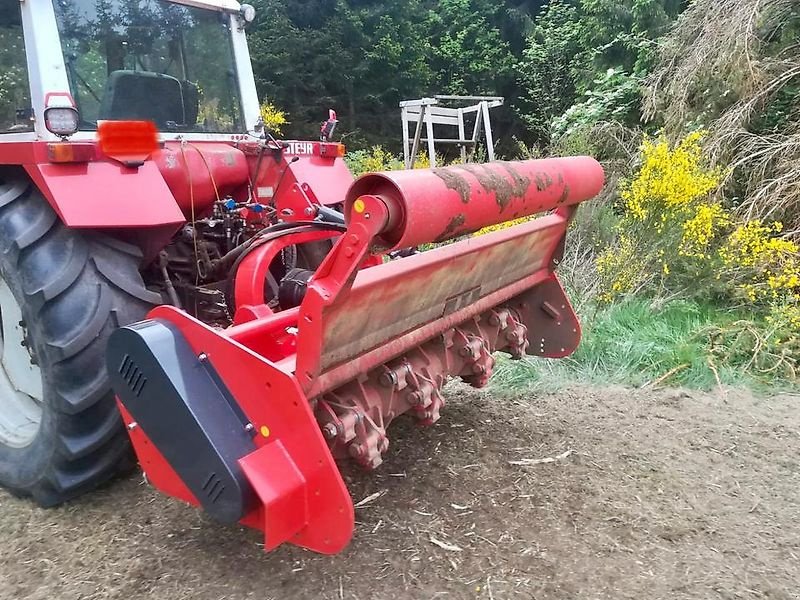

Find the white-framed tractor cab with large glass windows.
[{"left": 0, "top": 0, "right": 259, "bottom": 139}]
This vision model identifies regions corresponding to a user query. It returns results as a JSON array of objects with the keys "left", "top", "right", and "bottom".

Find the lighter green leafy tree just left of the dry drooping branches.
[{"left": 515, "top": 0, "right": 683, "bottom": 144}]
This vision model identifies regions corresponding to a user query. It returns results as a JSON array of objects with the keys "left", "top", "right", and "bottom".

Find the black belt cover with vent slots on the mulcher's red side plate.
[{"left": 106, "top": 320, "right": 256, "bottom": 523}]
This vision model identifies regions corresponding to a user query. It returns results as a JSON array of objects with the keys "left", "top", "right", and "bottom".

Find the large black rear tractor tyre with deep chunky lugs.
[{"left": 0, "top": 169, "right": 161, "bottom": 507}]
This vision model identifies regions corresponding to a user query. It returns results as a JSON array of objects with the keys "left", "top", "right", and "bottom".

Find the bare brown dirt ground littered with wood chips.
[{"left": 0, "top": 387, "right": 800, "bottom": 600}]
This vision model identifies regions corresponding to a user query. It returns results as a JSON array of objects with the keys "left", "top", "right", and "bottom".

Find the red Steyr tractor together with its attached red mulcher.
[{"left": 0, "top": 0, "right": 603, "bottom": 553}]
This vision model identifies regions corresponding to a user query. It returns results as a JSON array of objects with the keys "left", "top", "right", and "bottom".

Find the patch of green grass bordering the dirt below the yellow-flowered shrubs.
[{"left": 493, "top": 299, "right": 796, "bottom": 392}]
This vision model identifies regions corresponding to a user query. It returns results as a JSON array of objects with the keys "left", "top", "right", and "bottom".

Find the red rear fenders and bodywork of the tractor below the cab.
[{"left": 0, "top": 137, "right": 353, "bottom": 240}]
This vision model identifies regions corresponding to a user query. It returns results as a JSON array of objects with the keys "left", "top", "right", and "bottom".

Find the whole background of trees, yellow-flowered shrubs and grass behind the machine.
[{"left": 251, "top": 0, "right": 800, "bottom": 389}]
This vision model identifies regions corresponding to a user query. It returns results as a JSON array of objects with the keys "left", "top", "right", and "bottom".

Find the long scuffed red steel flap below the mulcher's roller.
[{"left": 304, "top": 209, "right": 572, "bottom": 398}]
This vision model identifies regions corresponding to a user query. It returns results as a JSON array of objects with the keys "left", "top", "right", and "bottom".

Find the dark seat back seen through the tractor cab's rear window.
[{"left": 98, "top": 71, "right": 199, "bottom": 129}]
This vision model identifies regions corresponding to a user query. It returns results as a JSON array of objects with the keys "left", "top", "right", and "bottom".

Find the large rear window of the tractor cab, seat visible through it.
[{"left": 54, "top": 0, "right": 244, "bottom": 133}]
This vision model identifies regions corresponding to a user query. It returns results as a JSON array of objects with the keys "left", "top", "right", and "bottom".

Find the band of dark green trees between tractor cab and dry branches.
[{"left": 245, "top": 0, "right": 675, "bottom": 152}]
